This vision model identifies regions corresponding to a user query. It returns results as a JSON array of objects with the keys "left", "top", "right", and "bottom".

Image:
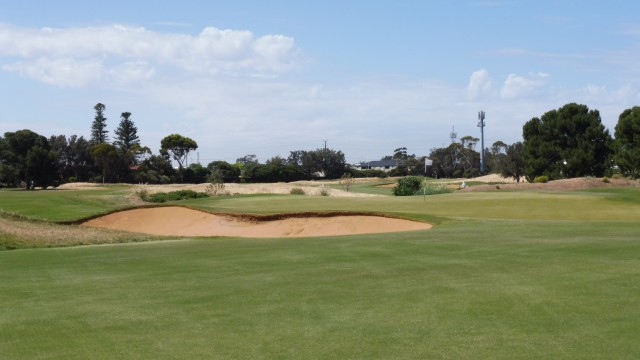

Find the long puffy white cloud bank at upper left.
[{"left": 0, "top": 24, "right": 302, "bottom": 86}]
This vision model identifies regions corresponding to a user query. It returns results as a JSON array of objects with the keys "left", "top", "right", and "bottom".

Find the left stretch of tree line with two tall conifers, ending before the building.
[{"left": 0, "top": 103, "right": 347, "bottom": 188}]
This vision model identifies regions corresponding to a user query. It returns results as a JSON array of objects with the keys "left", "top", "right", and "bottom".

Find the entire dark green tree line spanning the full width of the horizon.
[{"left": 0, "top": 103, "right": 640, "bottom": 188}]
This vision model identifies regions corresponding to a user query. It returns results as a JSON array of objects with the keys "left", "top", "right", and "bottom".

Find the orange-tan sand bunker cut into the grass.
[{"left": 82, "top": 207, "right": 431, "bottom": 238}]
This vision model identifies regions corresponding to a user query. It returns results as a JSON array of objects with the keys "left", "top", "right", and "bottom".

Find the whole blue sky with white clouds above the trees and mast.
[{"left": 0, "top": 0, "right": 640, "bottom": 165}]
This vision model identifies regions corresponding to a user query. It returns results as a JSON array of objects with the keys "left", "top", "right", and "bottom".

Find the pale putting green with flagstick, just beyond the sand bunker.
[{"left": 184, "top": 188, "right": 640, "bottom": 221}]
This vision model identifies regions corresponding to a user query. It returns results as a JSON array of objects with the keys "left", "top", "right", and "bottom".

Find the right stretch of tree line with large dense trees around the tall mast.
[{"left": 422, "top": 103, "right": 640, "bottom": 181}]
